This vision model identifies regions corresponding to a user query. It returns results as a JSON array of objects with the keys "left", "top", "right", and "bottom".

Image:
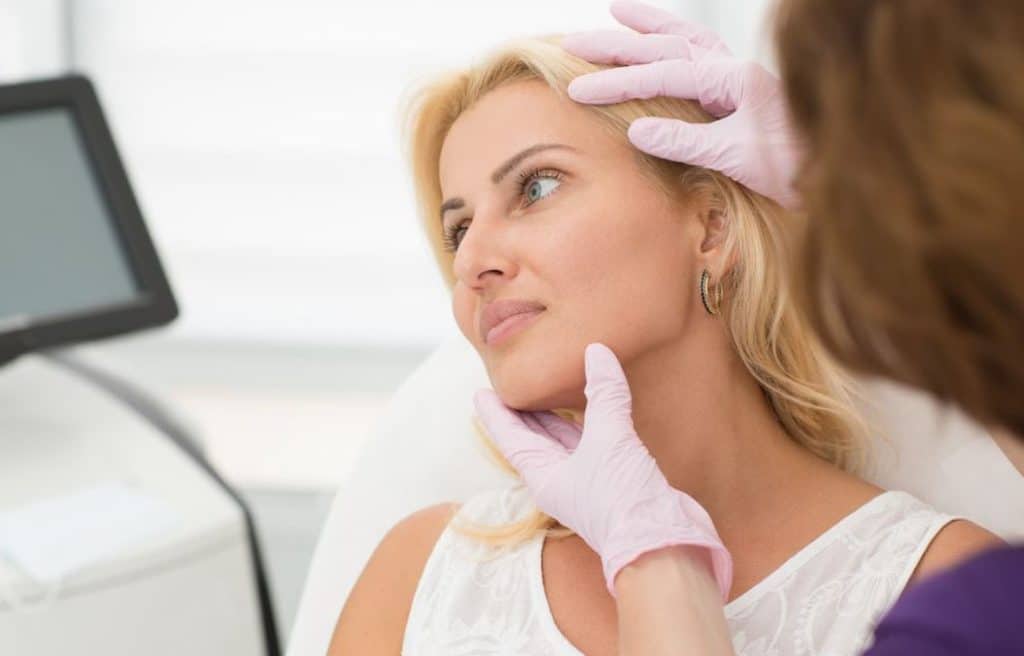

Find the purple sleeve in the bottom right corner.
[{"left": 865, "top": 546, "right": 1024, "bottom": 656}]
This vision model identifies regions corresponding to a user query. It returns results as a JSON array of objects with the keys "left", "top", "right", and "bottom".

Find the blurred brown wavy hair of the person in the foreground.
[{"left": 774, "top": 0, "right": 1024, "bottom": 436}]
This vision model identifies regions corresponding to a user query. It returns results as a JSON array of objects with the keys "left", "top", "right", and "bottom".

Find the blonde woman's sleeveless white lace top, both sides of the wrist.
[{"left": 401, "top": 483, "right": 957, "bottom": 656}]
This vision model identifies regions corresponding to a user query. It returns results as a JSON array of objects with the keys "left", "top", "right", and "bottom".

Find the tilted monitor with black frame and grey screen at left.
[{"left": 0, "top": 75, "right": 178, "bottom": 364}]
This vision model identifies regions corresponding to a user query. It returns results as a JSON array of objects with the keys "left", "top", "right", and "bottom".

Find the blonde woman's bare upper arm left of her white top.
[{"left": 328, "top": 504, "right": 458, "bottom": 656}]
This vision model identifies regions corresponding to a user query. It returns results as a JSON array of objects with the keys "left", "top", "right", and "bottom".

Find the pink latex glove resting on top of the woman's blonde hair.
[{"left": 561, "top": 0, "right": 801, "bottom": 209}]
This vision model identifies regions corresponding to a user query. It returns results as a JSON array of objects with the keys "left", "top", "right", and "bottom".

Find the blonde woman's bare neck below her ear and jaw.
[{"left": 610, "top": 340, "right": 835, "bottom": 537}]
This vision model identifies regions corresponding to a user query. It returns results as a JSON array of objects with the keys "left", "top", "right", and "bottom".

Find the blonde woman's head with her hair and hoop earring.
[{"left": 406, "top": 37, "right": 859, "bottom": 487}]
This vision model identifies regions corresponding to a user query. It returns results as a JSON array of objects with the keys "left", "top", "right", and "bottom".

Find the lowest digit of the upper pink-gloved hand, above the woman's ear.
[{"left": 627, "top": 112, "right": 743, "bottom": 173}]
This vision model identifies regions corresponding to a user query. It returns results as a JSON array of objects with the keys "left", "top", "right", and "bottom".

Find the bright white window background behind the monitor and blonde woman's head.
[{"left": 6, "top": 0, "right": 765, "bottom": 347}]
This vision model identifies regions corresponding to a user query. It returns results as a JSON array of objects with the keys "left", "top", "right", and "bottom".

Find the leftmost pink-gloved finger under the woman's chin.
[{"left": 473, "top": 390, "right": 568, "bottom": 480}]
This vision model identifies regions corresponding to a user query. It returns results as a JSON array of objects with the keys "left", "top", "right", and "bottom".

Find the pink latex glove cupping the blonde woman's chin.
[{"left": 473, "top": 343, "right": 732, "bottom": 603}]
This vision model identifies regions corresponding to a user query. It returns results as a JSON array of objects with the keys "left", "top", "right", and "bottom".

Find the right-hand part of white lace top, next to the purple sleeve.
[{"left": 725, "top": 490, "right": 958, "bottom": 656}]
